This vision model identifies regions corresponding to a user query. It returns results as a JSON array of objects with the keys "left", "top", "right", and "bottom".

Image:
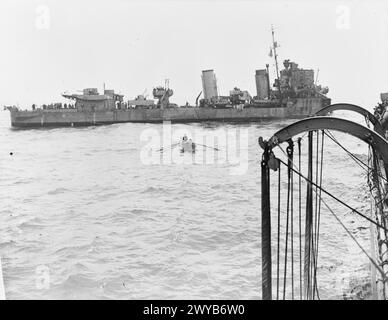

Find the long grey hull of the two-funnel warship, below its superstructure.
[{"left": 11, "top": 98, "right": 330, "bottom": 128}]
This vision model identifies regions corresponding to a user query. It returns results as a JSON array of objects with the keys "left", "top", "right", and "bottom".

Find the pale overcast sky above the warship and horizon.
[{"left": 0, "top": 0, "right": 388, "bottom": 108}]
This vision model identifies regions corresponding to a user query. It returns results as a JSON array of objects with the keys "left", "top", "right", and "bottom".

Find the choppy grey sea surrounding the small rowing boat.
[{"left": 0, "top": 111, "right": 376, "bottom": 299}]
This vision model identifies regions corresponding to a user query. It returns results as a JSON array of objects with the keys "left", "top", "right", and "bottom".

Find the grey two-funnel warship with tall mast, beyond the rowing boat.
[{"left": 5, "top": 30, "right": 331, "bottom": 128}]
